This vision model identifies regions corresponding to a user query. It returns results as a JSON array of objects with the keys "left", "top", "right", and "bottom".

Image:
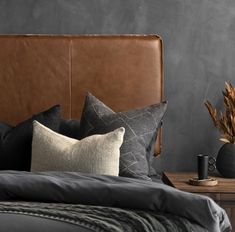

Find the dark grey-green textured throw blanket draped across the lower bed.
[{"left": 0, "top": 202, "right": 208, "bottom": 232}]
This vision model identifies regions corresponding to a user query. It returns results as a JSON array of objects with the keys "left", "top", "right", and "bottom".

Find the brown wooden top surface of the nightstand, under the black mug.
[{"left": 163, "top": 172, "right": 235, "bottom": 194}]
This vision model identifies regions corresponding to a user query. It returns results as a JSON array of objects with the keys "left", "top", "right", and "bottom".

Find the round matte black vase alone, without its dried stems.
[{"left": 216, "top": 143, "right": 235, "bottom": 178}]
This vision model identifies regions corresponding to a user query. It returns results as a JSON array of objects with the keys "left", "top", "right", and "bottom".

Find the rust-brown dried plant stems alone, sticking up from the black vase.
[{"left": 205, "top": 82, "right": 235, "bottom": 144}]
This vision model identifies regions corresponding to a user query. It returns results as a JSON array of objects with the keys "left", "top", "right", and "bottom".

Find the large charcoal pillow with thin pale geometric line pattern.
[{"left": 80, "top": 93, "right": 167, "bottom": 180}]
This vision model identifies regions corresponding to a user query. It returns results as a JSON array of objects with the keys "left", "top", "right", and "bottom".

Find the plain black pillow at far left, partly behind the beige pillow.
[{"left": 0, "top": 105, "right": 60, "bottom": 171}]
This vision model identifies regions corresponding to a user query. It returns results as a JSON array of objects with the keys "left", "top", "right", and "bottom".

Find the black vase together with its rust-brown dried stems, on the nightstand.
[{"left": 205, "top": 82, "right": 235, "bottom": 178}]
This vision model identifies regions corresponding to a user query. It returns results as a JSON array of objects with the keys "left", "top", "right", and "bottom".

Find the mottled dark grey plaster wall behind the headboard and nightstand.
[{"left": 0, "top": 0, "right": 235, "bottom": 170}]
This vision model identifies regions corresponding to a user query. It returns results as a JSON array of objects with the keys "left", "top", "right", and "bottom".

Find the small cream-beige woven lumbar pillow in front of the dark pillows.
[{"left": 31, "top": 121, "right": 125, "bottom": 176}]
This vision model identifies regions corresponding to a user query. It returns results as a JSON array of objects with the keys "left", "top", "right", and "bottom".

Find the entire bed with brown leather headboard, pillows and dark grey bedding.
[{"left": 0, "top": 35, "right": 231, "bottom": 232}]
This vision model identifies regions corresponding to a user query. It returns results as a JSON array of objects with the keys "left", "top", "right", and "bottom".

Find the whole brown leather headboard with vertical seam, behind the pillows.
[{"left": 0, "top": 35, "right": 163, "bottom": 153}]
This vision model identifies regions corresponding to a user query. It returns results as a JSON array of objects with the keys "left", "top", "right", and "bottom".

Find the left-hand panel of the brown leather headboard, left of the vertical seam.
[{"left": 0, "top": 36, "right": 71, "bottom": 124}]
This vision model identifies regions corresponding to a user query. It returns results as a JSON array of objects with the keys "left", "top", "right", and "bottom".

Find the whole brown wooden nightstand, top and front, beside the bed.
[{"left": 162, "top": 172, "right": 235, "bottom": 228}]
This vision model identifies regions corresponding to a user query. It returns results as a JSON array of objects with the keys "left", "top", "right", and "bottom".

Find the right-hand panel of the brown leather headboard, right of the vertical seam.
[{"left": 72, "top": 36, "right": 163, "bottom": 153}]
